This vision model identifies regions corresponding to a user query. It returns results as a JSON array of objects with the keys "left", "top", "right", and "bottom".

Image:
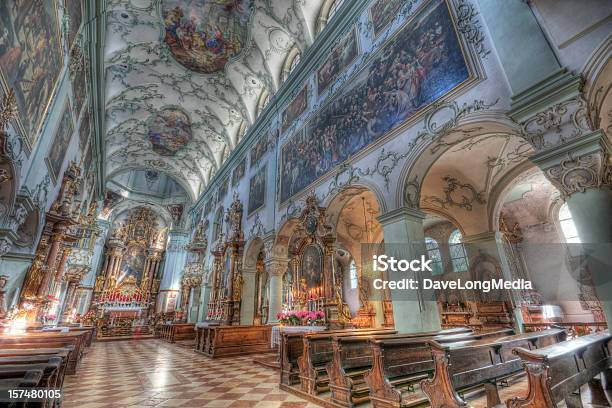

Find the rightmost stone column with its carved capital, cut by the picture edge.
[{"left": 530, "top": 129, "right": 612, "bottom": 325}]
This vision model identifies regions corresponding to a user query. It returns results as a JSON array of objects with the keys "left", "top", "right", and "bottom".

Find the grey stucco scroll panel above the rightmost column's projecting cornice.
[{"left": 522, "top": 97, "right": 593, "bottom": 151}]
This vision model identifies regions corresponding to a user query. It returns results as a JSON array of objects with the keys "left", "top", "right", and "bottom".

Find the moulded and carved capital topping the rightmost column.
[{"left": 530, "top": 129, "right": 612, "bottom": 199}]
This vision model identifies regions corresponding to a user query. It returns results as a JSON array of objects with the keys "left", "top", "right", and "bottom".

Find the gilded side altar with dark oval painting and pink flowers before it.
[{"left": 284, "top": 195, "right": 352, "bottom": 328}]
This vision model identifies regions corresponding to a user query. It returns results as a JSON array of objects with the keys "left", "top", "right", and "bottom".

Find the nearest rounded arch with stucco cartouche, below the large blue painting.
[{"left": 395, "top": 111, "right": 524, "bottom": 207}]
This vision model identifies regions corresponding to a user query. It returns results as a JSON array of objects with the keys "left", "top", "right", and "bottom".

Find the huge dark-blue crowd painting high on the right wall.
[{"left": 279, "top": 0, "right": 470, "bottom": 202}]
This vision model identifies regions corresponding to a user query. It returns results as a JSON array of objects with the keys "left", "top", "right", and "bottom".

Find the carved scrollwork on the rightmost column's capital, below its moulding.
[{"left": 546, "top": 152, "right": 612, "bottom": 199}]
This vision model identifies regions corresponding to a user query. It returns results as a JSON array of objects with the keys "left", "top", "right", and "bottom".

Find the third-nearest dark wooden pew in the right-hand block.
[{"left": 364, "top": 329, "right": 514, "bottom": 408}]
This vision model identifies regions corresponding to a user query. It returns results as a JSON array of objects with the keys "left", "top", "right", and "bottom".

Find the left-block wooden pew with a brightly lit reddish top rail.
[{"left": 0, "top": 331, "right": 87, "bottom": 374}]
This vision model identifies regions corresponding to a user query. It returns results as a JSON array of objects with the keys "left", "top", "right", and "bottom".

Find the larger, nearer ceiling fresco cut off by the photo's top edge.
[{"left": 162, "top": 0, "right": 254, "bottom": 74}]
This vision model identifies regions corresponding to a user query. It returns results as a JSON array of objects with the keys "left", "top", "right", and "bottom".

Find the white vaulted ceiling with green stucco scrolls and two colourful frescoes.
[{"left": 104, "top": 0, "right": 329, "bottom": 199}]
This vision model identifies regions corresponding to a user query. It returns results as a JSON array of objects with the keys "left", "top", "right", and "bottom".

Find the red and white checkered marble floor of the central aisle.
[{"left": 63, "top": 340, "right": 316, "bottom": 408}]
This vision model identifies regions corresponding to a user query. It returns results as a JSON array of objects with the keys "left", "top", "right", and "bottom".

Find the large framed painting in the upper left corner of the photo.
[{"left": 0, "top": 0, "right": 64, "bottom": 146}]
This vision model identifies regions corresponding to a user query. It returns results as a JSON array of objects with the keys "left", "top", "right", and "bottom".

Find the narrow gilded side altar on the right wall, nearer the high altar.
[{"left": 207, "top": 196, "right": 244, "bottom": 325}]
